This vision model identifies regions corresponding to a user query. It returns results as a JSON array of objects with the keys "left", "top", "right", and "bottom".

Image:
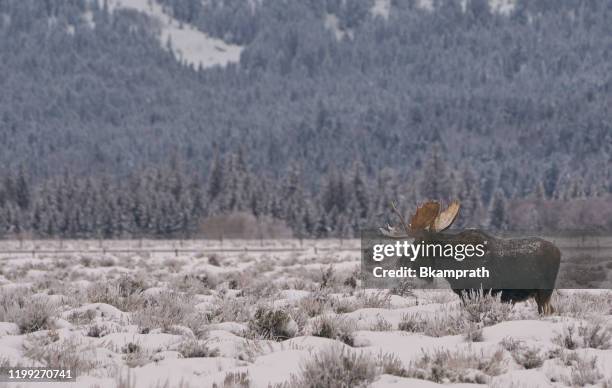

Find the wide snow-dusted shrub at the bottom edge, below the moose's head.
[{"left": 407, "top": 349, "right": 506, "bottom": 384}]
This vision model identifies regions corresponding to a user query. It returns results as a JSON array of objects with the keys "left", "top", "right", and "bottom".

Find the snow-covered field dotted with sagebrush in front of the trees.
[{"left": 0, "top": 240, "right": 612, "bottom": 388}]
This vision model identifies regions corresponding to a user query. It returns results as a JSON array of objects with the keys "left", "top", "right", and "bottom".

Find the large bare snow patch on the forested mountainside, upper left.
[{"left": 108, "top": 0, "right": 242, "bottom": 67}]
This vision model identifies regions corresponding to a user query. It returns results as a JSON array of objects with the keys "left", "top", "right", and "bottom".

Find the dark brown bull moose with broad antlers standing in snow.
[{"left": 383, "top": 201, "right": 561, "bottom": 314}]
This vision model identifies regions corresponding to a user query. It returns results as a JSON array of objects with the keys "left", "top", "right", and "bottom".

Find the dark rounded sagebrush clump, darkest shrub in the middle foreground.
[{"left": 249, "top": 306, "right": 298, "bottom": 340}]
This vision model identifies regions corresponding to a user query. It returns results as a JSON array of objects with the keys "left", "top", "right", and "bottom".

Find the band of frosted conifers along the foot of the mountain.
[{"left": 0, "top": 147, "right": 612, "bottom": 238}]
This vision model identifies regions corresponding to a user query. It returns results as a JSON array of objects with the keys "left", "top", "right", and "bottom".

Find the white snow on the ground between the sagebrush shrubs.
[{"left": 0, "top": 240, "right": 612, "bottom": 388}]
